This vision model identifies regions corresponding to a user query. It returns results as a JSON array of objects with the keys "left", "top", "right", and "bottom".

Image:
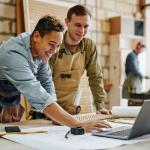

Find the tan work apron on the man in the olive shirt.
[{"left": 53, "top": 51, "right": 85, "bottom": 114}]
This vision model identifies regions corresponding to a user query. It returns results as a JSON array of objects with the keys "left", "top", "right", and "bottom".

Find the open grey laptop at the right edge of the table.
[{"left": 92, "top": 100, "right": 150, "bottom": 140}]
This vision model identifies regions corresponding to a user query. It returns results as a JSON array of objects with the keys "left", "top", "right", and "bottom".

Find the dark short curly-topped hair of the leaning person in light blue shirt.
[{"left": 32, "top": 15, "right": 64, "bottom": 37}]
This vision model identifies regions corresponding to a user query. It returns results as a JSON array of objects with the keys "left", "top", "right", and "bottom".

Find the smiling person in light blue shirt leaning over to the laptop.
[{"left": 0, "top": 15, "right": 110, "bottom": 131}]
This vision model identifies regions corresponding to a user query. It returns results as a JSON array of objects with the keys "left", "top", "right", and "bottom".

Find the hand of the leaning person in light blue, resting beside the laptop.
[{"left": 81, "top": 120, "right": 111, "bottom": 132}]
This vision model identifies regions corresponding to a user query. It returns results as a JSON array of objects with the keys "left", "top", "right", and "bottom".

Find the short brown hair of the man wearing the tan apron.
[{"left": 67, "top": 5, "right": 91, "bottom": 20}]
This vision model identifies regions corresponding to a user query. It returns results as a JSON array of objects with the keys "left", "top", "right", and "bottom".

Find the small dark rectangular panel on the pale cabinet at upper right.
[{"left": 134, "top": 20, "right": 144, "bottom": 36}]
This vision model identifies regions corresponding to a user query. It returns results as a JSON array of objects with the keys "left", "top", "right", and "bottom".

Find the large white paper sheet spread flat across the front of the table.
[{"left": 4, "top": 124, "right": 150, "bottom": 150}]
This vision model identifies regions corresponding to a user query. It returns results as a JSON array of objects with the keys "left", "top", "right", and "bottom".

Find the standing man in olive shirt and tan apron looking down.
[{"left": 49, "top": 5, "right": 110, "bottom": 114}]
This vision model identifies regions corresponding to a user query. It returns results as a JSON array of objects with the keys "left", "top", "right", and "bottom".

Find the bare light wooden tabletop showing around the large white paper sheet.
[{"left": 0, "top": 119, "right": 150, "bottom": 150}]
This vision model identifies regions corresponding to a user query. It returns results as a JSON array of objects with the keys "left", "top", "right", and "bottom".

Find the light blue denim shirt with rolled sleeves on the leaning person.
[{"left": 0, "top": 33, "right": 56, "bottom": 112}]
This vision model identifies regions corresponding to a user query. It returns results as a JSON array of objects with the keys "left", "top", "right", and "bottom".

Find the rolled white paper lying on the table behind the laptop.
[{"left": 112, "top": 106, "right": 141, "bottom": 117}]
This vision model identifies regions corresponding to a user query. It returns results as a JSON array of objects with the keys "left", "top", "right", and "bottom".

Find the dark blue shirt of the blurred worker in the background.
[{"left": 125, "top": 50, "right": 143, "bottom": 79}]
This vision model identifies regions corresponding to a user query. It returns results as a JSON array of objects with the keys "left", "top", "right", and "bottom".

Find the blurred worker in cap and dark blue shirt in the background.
[{"left": 122, "top": 41, "right": 149, "bottom": 105}]
